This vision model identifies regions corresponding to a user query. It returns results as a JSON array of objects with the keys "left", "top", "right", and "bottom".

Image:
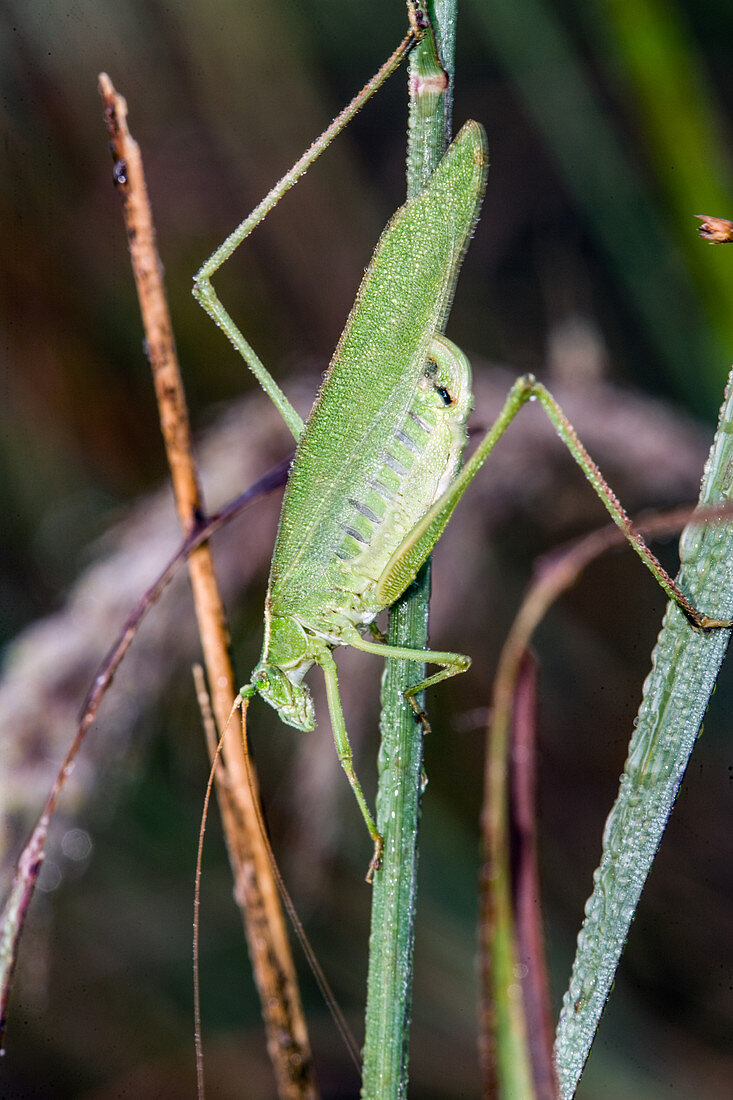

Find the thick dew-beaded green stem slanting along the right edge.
[{"left": 556, "top": 374, "right": 733, "bottom": 1100}]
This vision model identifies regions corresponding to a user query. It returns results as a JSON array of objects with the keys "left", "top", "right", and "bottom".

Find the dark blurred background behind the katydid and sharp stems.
[{"left": 0, "top": 0, "right": 733, "bottom": 1098}]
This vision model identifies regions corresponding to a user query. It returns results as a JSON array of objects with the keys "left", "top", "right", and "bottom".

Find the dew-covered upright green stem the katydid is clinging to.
[{"left": 362, "top": 0, "right": 457, "bottom": 1100}]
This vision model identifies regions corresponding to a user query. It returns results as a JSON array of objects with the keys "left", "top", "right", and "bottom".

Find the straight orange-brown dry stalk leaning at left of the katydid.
[{"left": 99, "top": 74, "right": 316, "bottom": 1098}]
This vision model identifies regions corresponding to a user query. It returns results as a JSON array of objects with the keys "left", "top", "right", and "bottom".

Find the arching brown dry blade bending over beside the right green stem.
[{"left": 479, "top": 505, "right": 733, "bottom": 1097}]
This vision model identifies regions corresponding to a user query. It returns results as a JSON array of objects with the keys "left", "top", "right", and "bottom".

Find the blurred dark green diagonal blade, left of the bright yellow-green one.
[{"left": 464, "top": 0, "right": 724, "bottom": 416}]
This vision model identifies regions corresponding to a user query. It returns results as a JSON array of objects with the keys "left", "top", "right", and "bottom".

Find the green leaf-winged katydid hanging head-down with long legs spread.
[{"left": 194, "top": 8, "right": 731, "bottom": 877}]
